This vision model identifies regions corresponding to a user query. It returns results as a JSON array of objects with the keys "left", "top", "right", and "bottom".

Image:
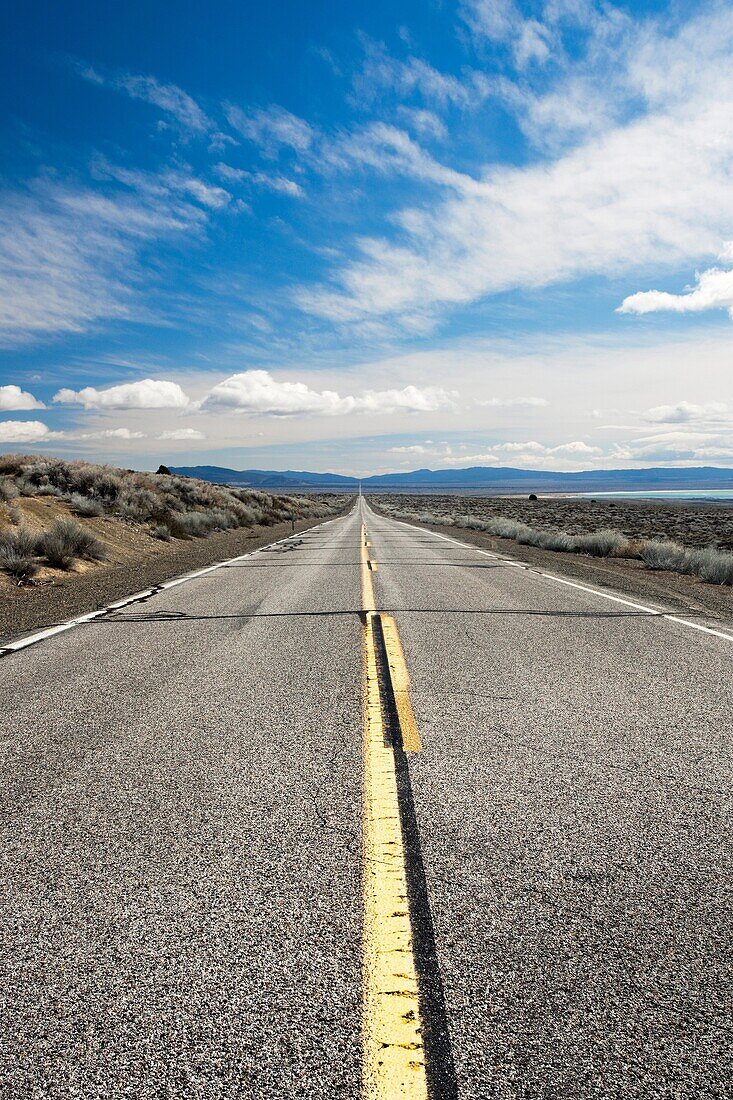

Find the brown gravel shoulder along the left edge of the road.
[{"left": 0, "top": 518, "right": 324, "bottom": 641}]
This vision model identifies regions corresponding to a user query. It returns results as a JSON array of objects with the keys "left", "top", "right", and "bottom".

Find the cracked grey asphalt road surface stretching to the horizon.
[{"left": 0, "top": 501, "right": 733, "bottom": 1100}]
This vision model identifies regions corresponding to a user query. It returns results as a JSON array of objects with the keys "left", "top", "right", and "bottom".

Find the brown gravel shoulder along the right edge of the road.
[{"left": 370, "top": 502, "right": 733, "bottom": 628}]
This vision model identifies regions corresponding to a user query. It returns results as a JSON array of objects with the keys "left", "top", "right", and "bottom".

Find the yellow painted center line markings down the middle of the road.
[{"left": 361, "top": 525, "right": 428, "bottom": 1100}]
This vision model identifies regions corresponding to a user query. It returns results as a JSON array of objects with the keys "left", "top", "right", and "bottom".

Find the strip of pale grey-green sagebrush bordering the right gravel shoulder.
[{"left": 379, "top": 498, "right": 733, "bottom": 585}]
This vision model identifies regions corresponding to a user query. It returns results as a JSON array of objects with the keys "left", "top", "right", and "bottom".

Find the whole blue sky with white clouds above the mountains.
[{"left": 0, "top": 0, "right": 733, "bottom": 473}]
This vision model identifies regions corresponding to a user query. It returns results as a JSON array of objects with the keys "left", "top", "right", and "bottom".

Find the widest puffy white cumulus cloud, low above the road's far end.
[{"left": 201, "top": 371, "right": 453, "bottom": 417}]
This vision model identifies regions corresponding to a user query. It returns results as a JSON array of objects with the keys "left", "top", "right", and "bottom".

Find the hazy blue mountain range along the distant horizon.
[{"left": 171, "top": 466, "right": 733, "bottom": 493}]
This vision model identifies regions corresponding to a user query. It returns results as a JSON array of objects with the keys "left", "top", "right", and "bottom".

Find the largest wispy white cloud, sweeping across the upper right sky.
[{"left": 296, "top": 9, "right": 733, "bottom": 322}]
